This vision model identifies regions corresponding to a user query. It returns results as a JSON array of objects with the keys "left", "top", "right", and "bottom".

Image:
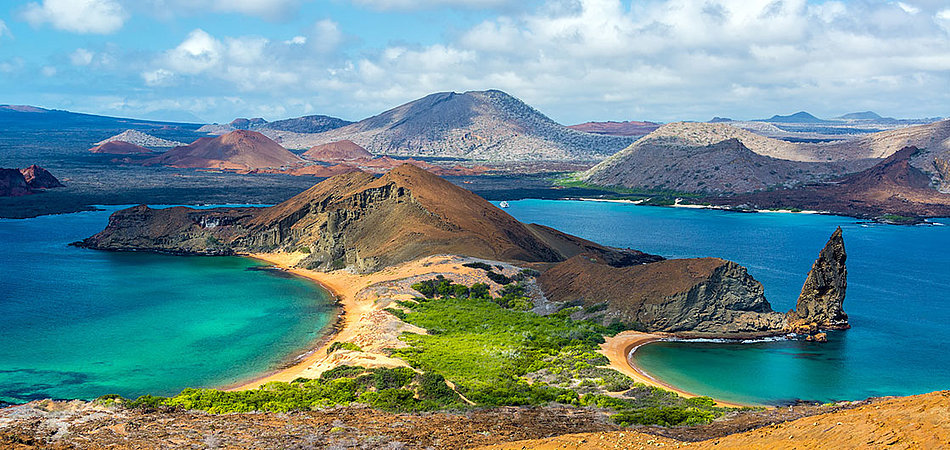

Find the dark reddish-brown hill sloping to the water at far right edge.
[{"left": 706, "top": 147, "right": 950, "bottom": 218}]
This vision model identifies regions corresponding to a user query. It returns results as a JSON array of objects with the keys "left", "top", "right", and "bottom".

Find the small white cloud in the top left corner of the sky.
[{"left": 22, "top": 0, "right": 128, "bottom": 34}]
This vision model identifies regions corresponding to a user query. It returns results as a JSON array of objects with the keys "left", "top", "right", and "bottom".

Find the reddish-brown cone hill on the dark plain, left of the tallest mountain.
[{"left": 145, "top": 130, "right": 302, "bottom": 170}]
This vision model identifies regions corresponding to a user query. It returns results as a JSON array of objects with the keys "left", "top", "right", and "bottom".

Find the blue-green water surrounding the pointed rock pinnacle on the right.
[{"left": 506, "top": 200, "right": 950, "bottom": 404}]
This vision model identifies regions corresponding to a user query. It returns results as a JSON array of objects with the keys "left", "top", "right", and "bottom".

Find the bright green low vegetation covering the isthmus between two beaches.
[{"left": 113, "top": 276, "right": 724, "bottom": 426}]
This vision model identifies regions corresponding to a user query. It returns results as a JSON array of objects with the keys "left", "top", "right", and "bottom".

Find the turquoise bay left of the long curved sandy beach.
[{"left": 0, "top": 208, "right": 335, "bottom": 402}]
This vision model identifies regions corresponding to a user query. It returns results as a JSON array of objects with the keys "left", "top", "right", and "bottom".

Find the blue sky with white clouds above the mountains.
[{"left": 0, "top": 0, "right": 950, "bottom": 124}]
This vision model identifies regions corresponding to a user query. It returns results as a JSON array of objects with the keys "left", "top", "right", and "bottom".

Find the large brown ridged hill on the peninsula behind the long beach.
[{"left": 78, "top": 164, "right": 658, "bottom": 272}]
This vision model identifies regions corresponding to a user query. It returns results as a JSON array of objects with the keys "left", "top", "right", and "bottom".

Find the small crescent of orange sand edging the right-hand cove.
[{"left": 600, "top": 331, "right": 763, "bottom": 408}]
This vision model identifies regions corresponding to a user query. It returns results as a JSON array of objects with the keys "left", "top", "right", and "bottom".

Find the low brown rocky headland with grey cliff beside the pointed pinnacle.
[{"left": 538, "top": 255, "right": 785, "bottom": 338}]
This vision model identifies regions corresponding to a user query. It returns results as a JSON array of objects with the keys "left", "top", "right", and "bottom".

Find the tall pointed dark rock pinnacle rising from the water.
[{"left": 788, "top": 227, "right": 851, "bottom": 334}]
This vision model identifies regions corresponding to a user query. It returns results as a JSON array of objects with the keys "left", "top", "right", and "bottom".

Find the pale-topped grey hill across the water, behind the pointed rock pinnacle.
[{"left": 580, "top": 122, "right": 869, "bottom": 192}]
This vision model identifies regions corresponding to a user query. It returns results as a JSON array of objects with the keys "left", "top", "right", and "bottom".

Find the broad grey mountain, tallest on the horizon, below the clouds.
[{"left": 272, "top": 90, "right": 633, "bottom": 161}]
